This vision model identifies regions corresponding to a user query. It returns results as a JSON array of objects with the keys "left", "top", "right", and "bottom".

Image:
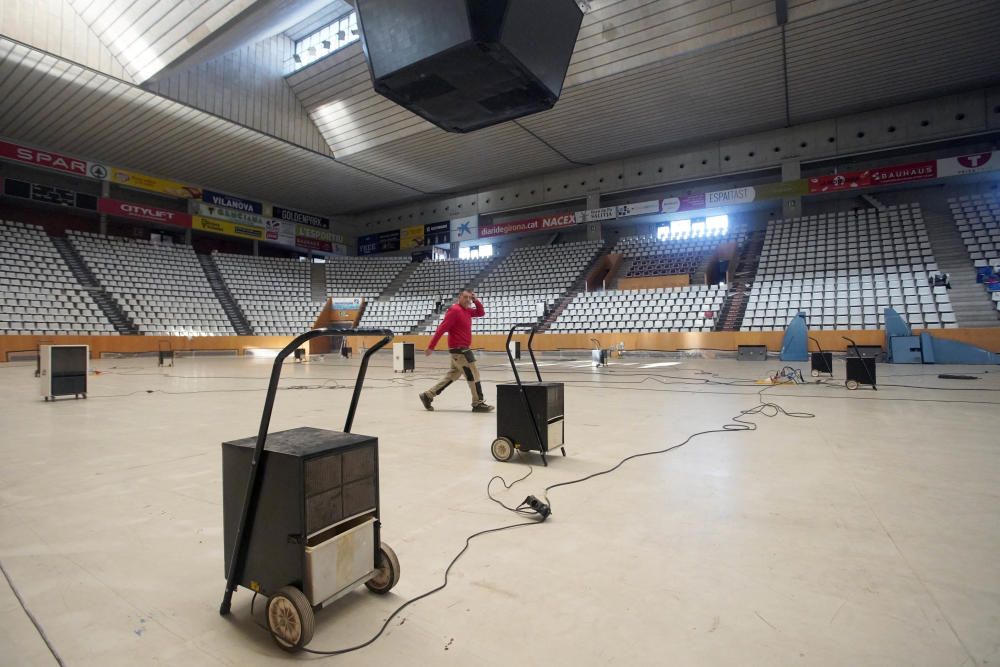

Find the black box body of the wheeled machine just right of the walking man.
[{"left": 497, "top": 382, "right": 565, "bottom": 451}]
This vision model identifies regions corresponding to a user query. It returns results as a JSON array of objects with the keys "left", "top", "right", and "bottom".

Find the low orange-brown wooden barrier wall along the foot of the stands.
[{"left": 0, "top": 327, "right": 1000, "bottom": 361}]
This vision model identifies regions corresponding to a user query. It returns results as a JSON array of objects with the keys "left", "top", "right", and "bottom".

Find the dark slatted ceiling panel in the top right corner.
[{"left": 788, "top": 0, "right": 1000, "bottom": 122}]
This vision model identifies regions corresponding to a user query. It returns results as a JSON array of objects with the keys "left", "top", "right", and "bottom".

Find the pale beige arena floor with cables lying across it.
[{"left": 0, "top": 354, "right": 1000, "bottom": 667}]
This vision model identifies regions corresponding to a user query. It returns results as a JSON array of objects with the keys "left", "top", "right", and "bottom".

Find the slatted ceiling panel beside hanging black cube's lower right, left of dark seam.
[{"left": 520, "top": 28, "right": 785, "bottom": 162}]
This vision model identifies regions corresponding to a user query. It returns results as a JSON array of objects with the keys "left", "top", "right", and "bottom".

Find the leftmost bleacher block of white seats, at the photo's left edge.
[{"left": 0, "top": 221, "right": 116, "bottom": 336}]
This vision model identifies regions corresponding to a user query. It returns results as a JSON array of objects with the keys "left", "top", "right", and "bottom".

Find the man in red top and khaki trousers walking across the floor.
[{"left": 420, "top": 289, "right": 493, "bottom": 412}]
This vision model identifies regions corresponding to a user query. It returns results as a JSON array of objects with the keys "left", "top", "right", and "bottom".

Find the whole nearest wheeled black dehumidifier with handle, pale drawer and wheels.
[{"left": 219, "top": 328, "right": 399, "bottom": 651}]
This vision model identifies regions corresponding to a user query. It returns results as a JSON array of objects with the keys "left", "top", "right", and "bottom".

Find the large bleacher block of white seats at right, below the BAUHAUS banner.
[{"left": 740, "top": 204, "right": 956, "bottom": 331}]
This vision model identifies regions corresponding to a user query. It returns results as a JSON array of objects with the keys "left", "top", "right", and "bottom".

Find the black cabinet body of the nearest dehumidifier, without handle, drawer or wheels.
[{"left": 222, "top": 427, "right": 379, "bottom": 602}]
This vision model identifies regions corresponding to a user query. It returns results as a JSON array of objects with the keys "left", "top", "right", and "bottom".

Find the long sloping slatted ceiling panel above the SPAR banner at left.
[{"left": 0, "top": 39, "right": 420, "bottom": 215}]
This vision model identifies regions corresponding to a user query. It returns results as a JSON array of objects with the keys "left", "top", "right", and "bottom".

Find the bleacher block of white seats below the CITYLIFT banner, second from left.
[{"left": 67, "top": 231, "right": 236, "bottom": 336}]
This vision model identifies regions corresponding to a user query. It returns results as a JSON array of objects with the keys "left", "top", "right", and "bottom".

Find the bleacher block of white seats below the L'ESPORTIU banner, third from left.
[{"left": 212, "top": 252, "right": 326, "bottom": 336}]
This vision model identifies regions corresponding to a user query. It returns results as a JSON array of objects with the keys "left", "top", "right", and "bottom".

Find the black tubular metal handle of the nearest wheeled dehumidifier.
[{"left": 219, "top": 327, "right": 393, "bottom": 616}]
